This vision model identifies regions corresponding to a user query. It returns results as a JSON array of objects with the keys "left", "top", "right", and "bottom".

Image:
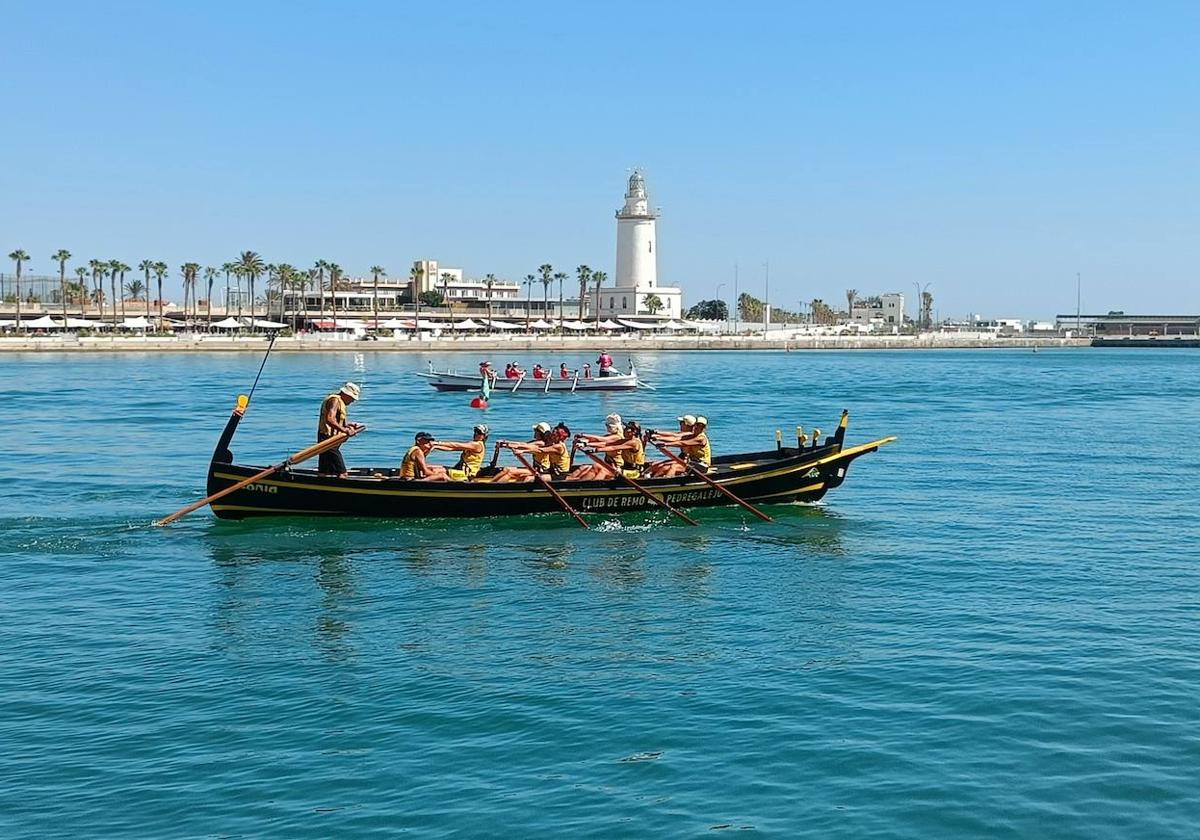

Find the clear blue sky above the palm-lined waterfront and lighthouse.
[{"left": 0, "top": 0, "right": 1200, "bottom": 317}]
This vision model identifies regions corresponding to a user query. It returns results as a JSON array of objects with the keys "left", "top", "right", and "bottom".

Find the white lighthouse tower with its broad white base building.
[{"left": 600, "top": 169, "right": 683, "bottom": 319}]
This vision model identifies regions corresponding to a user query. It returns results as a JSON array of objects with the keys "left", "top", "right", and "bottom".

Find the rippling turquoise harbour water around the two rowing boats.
[{"left": 0, "top": 350, "right": 1200, "bottom": 838}]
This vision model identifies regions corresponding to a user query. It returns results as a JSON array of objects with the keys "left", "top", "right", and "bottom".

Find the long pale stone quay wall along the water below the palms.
[{"left": 0, "top": 334, "right": 1091, "bottom": 353}]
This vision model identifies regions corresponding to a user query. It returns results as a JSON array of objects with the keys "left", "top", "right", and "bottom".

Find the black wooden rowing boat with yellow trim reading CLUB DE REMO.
[{"left": 208, "top": 410, "right": 895, "bottom": 520}]
